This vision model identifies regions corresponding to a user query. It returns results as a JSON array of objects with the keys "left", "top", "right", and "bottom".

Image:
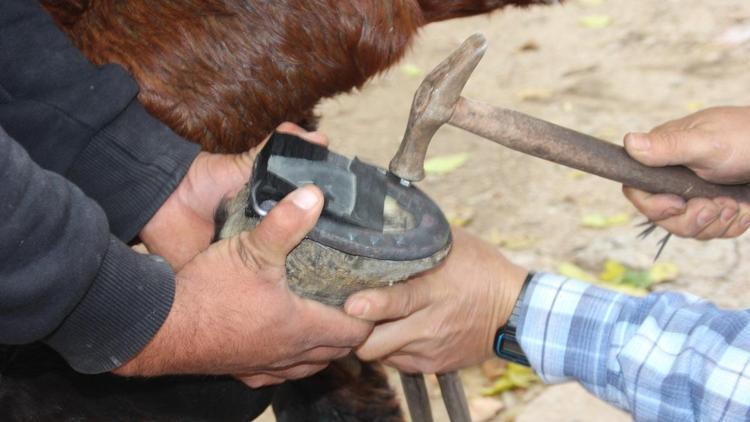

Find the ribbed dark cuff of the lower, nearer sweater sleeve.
[{"left": 45, "top": 238, "right": 175, "bottom": 374}]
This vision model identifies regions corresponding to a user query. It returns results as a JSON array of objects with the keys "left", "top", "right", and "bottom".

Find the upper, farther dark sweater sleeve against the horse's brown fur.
[{"left": 0, "top": 0, "right": 198, "bottom": 241}]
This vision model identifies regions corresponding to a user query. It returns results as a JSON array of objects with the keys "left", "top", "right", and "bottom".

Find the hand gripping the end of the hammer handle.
[{"left": 623, "top": 107, "right": 750, "bottom": 240}]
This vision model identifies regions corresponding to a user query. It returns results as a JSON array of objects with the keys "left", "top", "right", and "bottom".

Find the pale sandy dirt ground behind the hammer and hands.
[{"left": 264, "top": 0, "right": 750, "bottom": 422}]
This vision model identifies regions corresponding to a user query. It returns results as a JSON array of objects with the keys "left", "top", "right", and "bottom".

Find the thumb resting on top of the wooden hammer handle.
[{"left": 625, "top": 129, "right": 712, "bottom": 168}]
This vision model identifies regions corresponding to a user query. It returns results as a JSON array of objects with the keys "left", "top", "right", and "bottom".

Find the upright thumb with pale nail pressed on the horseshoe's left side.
[{"left": 240, "top": 185, "right": 323, "bottom": 266}]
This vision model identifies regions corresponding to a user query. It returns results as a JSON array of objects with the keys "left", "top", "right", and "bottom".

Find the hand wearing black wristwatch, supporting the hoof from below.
[{"left": 345, "top": 230, "right": 527, "bottom": 373}]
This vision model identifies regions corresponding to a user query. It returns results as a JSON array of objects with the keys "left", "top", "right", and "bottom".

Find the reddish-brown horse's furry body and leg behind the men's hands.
[{"left": 23, "top": 0, "right": 550, "bottom": 421}]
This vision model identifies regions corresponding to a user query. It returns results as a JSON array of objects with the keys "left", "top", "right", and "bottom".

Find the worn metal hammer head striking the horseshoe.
[{"left": 389, "top": 34, "right": 487, "bottom": 181}]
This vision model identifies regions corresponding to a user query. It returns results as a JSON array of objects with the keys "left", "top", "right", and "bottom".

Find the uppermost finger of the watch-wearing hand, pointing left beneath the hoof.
[{"left": 344, "top": 280, "right": 430, "bottom": 322}]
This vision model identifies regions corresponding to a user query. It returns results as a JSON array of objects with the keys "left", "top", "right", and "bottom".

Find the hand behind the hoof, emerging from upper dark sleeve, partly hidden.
[{"left": 140, "top": 123, "right": 328, "bottom": 270}]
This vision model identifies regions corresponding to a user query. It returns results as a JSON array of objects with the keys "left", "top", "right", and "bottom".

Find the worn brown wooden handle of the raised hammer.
[{"left": 449, "top": 97, "right": 750, "bottom": 202}]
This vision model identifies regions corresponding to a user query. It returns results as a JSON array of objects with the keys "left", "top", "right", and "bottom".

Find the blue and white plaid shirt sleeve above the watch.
[{"left": 517, "top": 273, "right": 750, "bottom": 421}]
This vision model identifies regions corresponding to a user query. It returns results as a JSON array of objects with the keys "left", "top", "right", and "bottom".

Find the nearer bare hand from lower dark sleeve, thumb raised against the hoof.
[{"left": 114, "top": 186, "right": 372, "bottom": 387}]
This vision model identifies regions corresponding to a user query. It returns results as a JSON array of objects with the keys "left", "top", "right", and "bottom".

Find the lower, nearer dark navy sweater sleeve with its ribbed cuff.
[{"left": 0, "top": 128, "right": 174, "bottom": 373}]
